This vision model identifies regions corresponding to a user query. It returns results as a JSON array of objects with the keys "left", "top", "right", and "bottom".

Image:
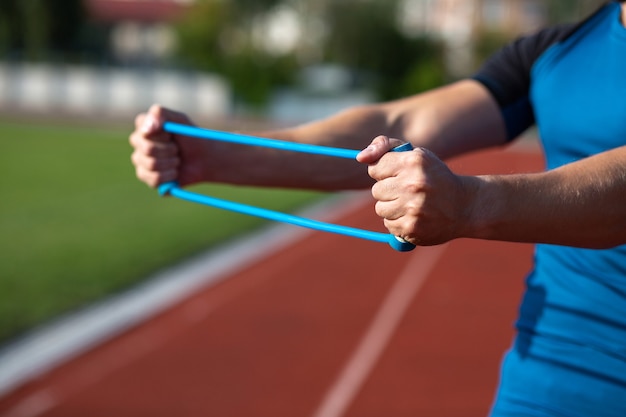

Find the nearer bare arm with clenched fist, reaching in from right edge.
[{"left": 369, "top": 141, "right": 626, "bottom": 248}]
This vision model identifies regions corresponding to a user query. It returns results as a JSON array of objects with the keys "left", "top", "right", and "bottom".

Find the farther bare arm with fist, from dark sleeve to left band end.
[{"left": 130, "top": 80, "right": 505, "bottom": 190}]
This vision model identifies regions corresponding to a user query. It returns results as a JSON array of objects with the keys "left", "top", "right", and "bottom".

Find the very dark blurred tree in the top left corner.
[{"left": 0, "top": 0, "right": 85, "bottom": 60}]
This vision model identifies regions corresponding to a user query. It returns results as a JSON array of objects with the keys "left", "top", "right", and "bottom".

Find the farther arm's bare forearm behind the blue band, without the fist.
[{"left": 208, "top": 105, "right": 388, "bottom": 190}]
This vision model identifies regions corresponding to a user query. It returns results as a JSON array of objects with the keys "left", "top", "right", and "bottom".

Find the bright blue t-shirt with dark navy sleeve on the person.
[{"left": 474, "top": 2, "right": 626, "bottom": 417}]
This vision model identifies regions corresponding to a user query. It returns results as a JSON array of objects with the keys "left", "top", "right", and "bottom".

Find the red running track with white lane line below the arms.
[{"left": 0, "top": 143, "right": 542, "bottom": 417}]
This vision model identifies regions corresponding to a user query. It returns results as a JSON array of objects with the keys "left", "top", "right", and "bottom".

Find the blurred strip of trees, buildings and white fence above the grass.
[{"left": 0, "top": 0, "right": 601, "bottom": 120}]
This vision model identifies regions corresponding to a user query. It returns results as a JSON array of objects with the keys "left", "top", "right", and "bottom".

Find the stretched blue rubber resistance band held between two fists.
[{"left": 159, "top": 122, "right": 415, "bottom": 252}]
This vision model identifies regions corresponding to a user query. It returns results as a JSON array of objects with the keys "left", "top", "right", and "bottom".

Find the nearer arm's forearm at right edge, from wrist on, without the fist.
[{"left": 464, "top": 147, "right": 626, "bottom": 248}]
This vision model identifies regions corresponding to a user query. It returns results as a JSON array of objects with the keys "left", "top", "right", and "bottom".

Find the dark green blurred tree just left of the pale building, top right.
[{"left": 323, "top": 0, "right": 445, "bottom": 99}]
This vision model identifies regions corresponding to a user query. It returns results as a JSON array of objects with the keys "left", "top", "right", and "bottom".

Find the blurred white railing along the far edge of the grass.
[{"left": 0, "top": 63, "right": 231, "bottom": 117}]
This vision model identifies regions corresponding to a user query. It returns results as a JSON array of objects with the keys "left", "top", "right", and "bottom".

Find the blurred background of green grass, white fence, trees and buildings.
[{"left": 0, "top": 0, "right": 603, "bottom": 358}]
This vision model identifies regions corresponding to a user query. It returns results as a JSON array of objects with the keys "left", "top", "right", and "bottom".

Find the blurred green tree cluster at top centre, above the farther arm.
[{"left": 178, "top": 0, "right": 444, "bottom": 106}]
